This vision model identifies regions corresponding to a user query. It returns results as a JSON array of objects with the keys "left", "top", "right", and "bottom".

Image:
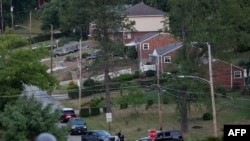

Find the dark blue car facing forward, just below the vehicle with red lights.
[{"left": 67, "top": 118, "right": 87, "bottom": 135}]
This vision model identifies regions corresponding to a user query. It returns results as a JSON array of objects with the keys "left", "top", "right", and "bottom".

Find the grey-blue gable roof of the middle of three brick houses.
[{"left": 153, "top": 42, "right": 182, "bottom": 56}]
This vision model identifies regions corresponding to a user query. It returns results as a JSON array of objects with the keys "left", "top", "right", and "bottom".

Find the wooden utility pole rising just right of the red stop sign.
[{"left": 157, "top": 56, "right": 162, "bottom": 130}]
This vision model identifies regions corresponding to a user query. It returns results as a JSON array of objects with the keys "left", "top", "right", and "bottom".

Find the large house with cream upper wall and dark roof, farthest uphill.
[{"left": 123, "top": 2, "right": 168, "bottom": 44}]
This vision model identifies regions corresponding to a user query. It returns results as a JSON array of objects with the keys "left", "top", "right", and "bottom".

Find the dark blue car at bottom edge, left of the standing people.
[{"left": 81, "top": 130, "right": 118, "bottom": 141}]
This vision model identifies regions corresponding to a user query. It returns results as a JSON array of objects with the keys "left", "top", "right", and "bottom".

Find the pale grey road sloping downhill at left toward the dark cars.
[{"left": 25, "top": 86, "right": 81, "bottom": 141}]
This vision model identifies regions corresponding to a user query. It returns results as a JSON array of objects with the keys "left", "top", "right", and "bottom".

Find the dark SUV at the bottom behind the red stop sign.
[{"left": 138, "top": 130, "right": 184, "bottom": 141}]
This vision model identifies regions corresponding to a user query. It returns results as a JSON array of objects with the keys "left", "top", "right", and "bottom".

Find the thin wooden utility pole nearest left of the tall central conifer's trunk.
[{"left": 78, "top": 39, "right": 82, "bottom": 111}]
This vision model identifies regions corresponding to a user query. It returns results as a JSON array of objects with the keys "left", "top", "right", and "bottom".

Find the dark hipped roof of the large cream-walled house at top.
[{"left": 125, "top": 2, "right": 165, "bottom": 16}]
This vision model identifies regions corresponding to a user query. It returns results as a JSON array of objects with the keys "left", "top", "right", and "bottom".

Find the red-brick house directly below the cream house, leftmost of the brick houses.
[{"left": 125, "top": 32, "right": 179, "bottom": 70}]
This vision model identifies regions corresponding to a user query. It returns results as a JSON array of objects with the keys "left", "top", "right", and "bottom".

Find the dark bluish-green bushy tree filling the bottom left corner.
[{"left": 0, "top": 96, "right": 67, "bottom": 141}]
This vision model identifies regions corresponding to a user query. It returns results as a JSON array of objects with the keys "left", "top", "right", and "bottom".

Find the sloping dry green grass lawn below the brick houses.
[{"left": 61, "top": 91, "right": 250, "bottom": 141}]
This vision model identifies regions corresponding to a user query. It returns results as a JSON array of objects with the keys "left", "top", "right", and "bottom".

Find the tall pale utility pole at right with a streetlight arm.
[{"left": 207, "top": 42, "right": 218, "bottom": 137}]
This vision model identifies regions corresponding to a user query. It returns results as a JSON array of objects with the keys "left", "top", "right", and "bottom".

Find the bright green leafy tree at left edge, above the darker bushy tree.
[{"left": 0, "top": 31, "right": 58, "bottom": 110}]
